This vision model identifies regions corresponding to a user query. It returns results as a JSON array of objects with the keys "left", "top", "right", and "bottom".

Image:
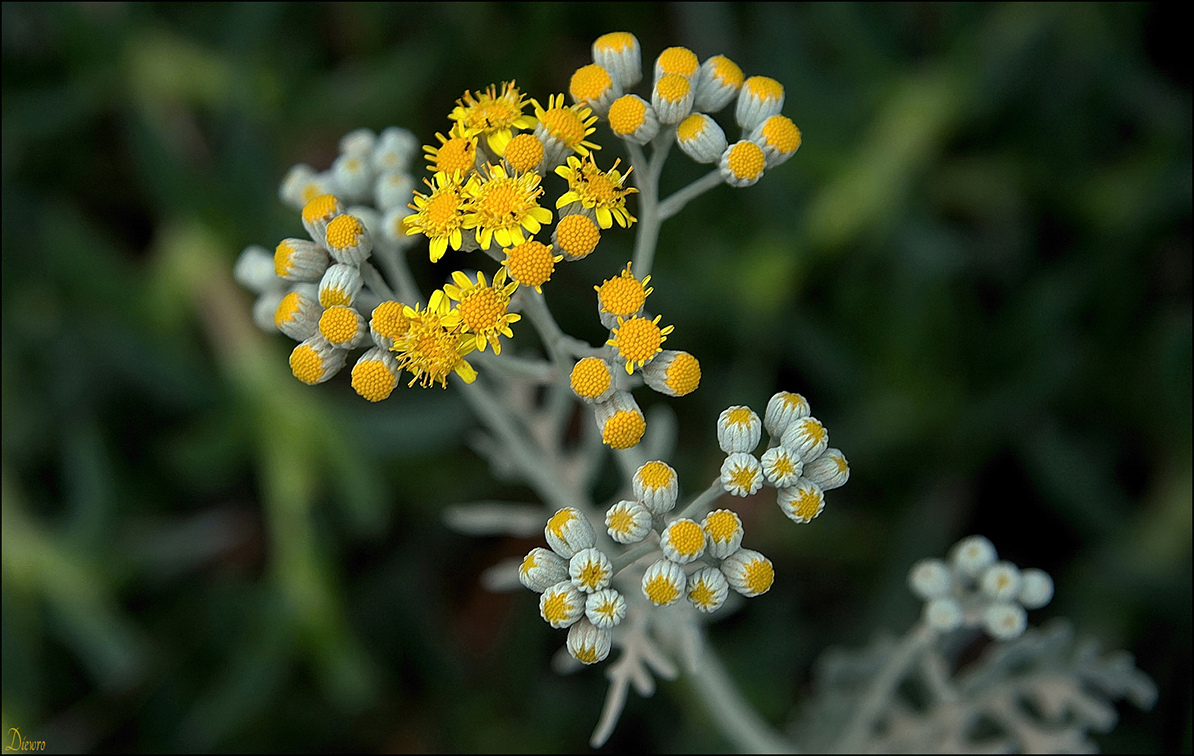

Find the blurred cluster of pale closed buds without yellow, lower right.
[{"left": 907, "top": 535, "right": 1053, "bottom": 640}]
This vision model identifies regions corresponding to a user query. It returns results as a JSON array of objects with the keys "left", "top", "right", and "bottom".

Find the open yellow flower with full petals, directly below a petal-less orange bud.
[{"left": 463, "top": 165, "right": 552, "bottom": 250}]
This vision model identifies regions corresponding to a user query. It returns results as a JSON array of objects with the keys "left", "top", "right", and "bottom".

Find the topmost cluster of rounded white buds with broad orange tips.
[{"left": 568, "top": 31, "right": 801, "bottom": 186}]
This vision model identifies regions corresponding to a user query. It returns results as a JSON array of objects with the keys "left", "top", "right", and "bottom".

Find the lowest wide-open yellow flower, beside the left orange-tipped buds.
[{"left": 393, "top": 289, "right": 476, "bottom": 388}]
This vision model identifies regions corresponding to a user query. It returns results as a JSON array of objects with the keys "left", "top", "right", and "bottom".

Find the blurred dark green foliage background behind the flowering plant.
[{"left": 2, "top": 2, "right": 1192, "bottom": 751}]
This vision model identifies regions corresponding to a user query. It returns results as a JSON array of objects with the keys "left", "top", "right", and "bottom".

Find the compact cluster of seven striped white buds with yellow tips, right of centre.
[{"left": 718, "top": 392, "right": 850, "bottom": 523}]
